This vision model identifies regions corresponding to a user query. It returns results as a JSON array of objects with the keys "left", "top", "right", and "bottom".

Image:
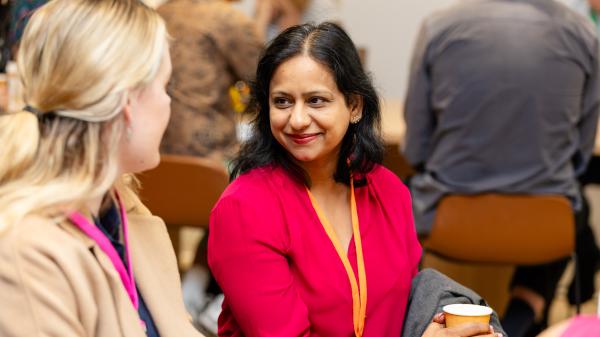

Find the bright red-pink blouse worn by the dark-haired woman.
[{"left": 208, "top": 166, "right": 421, "bottom": 337}]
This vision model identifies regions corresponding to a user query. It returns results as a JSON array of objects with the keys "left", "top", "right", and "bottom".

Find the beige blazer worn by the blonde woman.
[{"left": 0, "top": 192, "right": 202, "bottom": 337}]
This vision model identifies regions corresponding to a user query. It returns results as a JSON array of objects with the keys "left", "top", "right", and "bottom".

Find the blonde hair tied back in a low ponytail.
[{"left": 0, "top": 0, "right": 167, "bottom": 233}]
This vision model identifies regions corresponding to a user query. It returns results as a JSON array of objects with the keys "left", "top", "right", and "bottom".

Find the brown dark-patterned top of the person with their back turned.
[{"left": 158, "top": 0, "right": 262, "bottom": 158}]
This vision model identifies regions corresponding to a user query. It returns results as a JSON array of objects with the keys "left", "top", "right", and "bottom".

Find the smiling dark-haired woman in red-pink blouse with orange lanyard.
[{"left": 208, "top": 23, "right": 496, "bottom": 337}]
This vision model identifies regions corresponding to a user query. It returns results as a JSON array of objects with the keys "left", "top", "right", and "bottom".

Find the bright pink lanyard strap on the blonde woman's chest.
[{"left": 69, "top": 193, "right": 139, "bottom": 311}]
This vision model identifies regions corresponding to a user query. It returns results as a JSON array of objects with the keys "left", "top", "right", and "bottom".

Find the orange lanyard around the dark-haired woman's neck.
[{"left": 306, "top": 177, "right": 367, "bottom": 337}]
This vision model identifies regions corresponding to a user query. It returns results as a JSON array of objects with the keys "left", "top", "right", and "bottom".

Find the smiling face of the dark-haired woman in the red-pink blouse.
[{"left": 269, "top": 55, "right": 362, "bottom": 169}]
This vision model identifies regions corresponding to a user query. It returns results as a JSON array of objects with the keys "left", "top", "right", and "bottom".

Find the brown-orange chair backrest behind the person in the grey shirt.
[{"left": 424, "top": 194, "right": 575, "bottom": 265}]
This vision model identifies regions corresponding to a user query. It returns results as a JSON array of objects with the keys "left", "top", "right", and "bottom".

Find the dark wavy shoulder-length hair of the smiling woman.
[{"left": 231, "top": 22, "right": 384, "bottom": 186}]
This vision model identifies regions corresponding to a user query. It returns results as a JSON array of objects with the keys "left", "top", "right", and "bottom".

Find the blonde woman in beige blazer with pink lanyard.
[{"left": 0, "top": 0, "right": 199, "bottom": 337}]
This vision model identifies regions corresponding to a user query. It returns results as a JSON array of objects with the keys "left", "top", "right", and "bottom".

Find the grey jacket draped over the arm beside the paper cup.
[{"left": 402, "top": 269, "right": 506, "bottom": 337}]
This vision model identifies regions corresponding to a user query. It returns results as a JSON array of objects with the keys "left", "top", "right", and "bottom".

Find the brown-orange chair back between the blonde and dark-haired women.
[{"left": 138, "top": 155, "right": 229, "bottom": 262}]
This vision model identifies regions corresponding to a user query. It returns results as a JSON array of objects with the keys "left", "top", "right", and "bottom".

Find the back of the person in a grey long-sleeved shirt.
[{"left": 405, "top": 0, "right": 599, "bottom": 232}]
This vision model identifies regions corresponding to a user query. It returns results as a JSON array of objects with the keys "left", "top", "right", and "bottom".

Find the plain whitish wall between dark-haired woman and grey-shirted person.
[{"left": 341, "top": 0, "right": 456, "bottom": 99}]
